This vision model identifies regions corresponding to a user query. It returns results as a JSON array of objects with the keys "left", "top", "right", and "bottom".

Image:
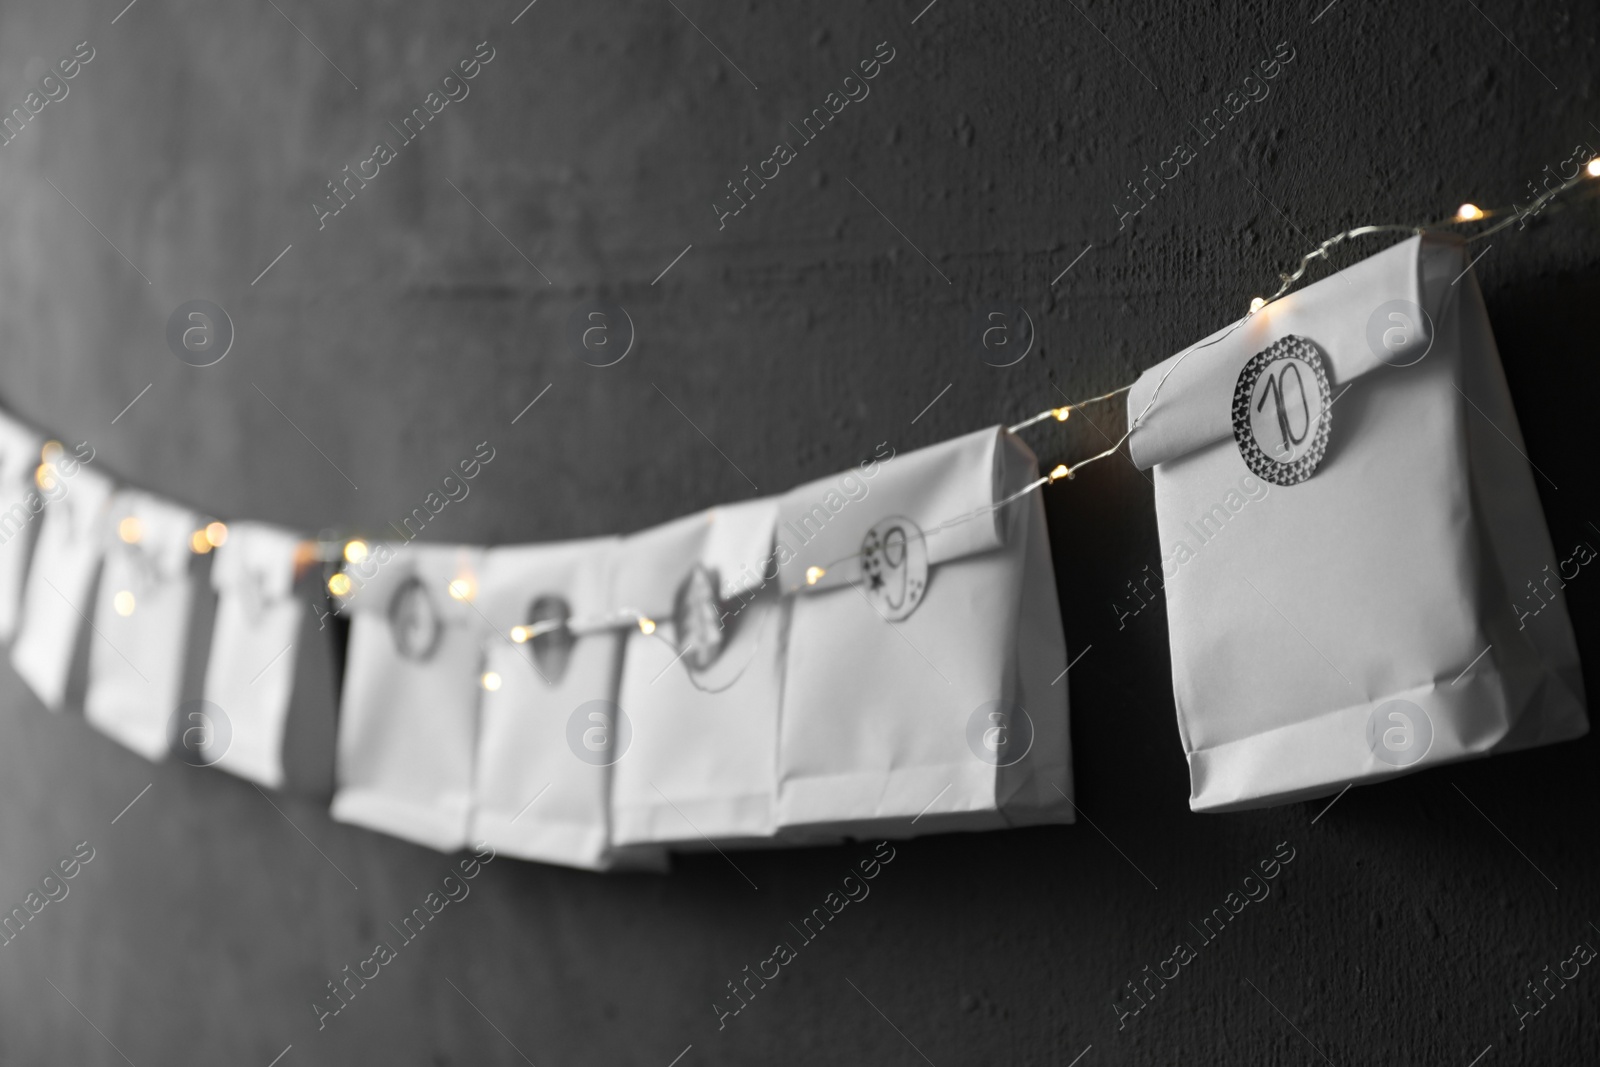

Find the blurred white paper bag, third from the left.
[{"left": 84, "top": 490, "right": 200, "bottom": 760}]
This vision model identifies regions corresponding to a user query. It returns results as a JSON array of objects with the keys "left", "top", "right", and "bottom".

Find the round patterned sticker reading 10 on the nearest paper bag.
[{"left": 1234, "top": 334, "right": 1333, "bottom": 485}]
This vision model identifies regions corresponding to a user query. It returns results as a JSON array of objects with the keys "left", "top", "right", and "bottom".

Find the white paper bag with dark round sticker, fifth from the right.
[{"left": 333, "top": 544, "right": 483, "bottom": 851}]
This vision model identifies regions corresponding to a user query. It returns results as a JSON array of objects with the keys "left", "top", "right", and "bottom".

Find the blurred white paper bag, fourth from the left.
[{"left": 197, "top": 522, "right": 307, "bottom": 789}]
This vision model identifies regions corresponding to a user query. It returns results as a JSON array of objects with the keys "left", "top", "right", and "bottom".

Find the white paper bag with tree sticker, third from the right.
[{"left": 611, "top": 499, "right": 784, "bottom": 849}]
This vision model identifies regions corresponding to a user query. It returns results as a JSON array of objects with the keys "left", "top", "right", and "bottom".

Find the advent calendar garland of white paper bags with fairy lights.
[{"left": 0, "top": 167, "right": 1600, "bottom": 869}]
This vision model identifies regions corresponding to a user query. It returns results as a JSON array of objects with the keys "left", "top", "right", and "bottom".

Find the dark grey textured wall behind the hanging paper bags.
[{"left": 0, "top": 0, "right": 1600, "bottom": 1067}]
